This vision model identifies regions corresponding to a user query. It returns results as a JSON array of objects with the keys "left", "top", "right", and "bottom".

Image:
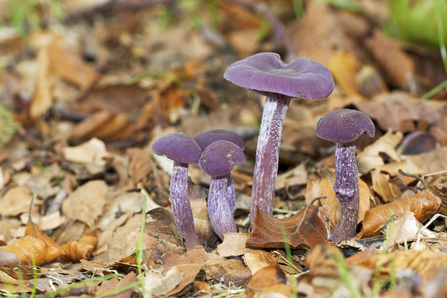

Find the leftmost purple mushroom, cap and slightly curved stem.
[{"left": 152, "top": 132, "right": 202, "bottom": 247}]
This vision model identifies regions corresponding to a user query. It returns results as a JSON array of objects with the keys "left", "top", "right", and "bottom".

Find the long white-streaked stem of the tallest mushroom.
[{"left": 250, "top": 95, "right": 291, "bottom": 230}]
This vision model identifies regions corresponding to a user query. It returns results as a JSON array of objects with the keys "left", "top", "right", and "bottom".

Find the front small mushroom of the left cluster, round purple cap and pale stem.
[{"left": 199, "top": 141, "right": 245, "bottom": 240}]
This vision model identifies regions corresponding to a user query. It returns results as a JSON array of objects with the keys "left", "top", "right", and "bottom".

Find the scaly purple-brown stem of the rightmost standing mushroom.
[{"left": 329, "top": 142, "right": 359, "bottom": 242}]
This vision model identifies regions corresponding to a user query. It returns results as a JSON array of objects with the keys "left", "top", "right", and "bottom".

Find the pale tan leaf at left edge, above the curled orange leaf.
[{"left": 0, "top": 186, "right": 42, "bottom": 216}]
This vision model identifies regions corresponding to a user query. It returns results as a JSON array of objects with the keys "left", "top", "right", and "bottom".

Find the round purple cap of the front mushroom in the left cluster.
[{"left": 199, "top": 141, "right": 245, "bottom": 176}]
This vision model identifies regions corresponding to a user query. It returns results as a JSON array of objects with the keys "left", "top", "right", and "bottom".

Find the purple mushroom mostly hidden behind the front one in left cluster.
[{"left": 193, "top": 129, "right": 245, "bottom": 213}]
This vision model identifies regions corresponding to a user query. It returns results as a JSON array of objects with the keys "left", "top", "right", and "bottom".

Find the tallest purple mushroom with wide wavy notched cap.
[{"left": 224, "top": 53, "right": 334, "bottom": 229}]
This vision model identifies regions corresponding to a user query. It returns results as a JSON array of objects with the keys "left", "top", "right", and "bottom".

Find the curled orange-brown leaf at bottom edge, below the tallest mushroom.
[{"left": 247, "top": 265, "right": 293, "bottom": 298}]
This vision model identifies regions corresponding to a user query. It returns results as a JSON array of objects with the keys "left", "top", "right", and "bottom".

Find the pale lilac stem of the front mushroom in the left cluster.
[{"left": 208, "top": 175, "right": 237, "bottom": 240}]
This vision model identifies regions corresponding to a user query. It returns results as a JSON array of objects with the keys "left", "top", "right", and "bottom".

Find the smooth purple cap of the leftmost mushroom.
[{"left": 152, "top": 132, "right": 202, "bottom": 164}]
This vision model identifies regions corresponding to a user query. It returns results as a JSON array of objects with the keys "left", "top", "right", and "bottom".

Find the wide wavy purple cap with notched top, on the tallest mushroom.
[{"left": 224, "top": 52, "right": 334, "bottom": 99}]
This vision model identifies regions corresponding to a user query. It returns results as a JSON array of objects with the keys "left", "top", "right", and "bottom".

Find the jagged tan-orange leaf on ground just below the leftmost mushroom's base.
[{"left": 162, "top": 246, "right": 205, "bottom": 296}]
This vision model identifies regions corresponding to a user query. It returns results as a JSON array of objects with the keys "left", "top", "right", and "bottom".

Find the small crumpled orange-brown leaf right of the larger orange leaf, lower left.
[{"left": 61, "top": 235, "right": 98, "bottom": 263}]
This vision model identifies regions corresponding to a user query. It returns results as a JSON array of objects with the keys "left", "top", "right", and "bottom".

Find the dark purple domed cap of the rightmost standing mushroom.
[{"left": 317, "top": 109, "right": 375, "bottom": 143}]
